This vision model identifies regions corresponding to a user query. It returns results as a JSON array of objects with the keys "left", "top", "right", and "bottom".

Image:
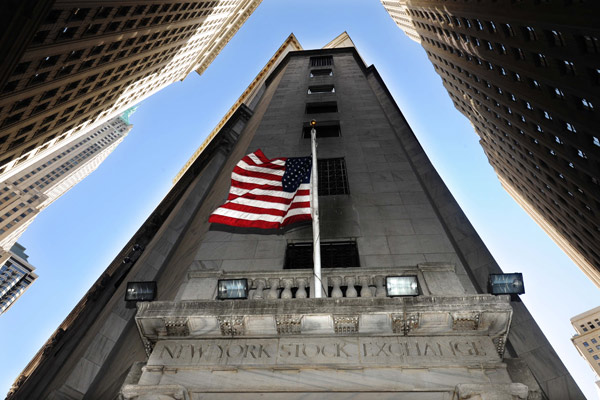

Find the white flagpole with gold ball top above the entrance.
[{"left": 310, "top": 119, "right": 323, "bottom": 298}]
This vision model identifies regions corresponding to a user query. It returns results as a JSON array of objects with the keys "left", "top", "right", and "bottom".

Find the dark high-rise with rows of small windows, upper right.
[{"left": 382, "top": 0, "right": 600, "bottom": 286}]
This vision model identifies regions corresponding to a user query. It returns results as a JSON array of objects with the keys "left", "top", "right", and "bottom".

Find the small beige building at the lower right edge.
[{"left": 571, "top": 307, "right": 600, "bottom": 392}]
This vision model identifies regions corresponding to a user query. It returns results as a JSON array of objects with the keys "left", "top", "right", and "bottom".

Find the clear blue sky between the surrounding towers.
[{"left": 0, "top": 0, "right": 600, "bottom": 398}]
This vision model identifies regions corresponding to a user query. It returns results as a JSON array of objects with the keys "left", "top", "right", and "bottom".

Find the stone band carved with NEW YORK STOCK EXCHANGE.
[{"left": 148, "top": 337, "right": 499, "bottom": 366}]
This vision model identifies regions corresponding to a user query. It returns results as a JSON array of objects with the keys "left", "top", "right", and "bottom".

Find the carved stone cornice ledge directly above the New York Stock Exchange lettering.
[{"left": 136, "top": 294, "right": 512, "bottom": 346}]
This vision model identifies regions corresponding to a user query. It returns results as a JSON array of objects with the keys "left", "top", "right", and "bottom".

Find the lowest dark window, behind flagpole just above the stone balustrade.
[{"left": 283, "top": 241, "right": 360, "bottom": 269}]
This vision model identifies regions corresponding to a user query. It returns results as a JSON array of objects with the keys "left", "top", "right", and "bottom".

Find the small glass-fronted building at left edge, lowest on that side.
[{"left": 0, "top": 243, "right": 38, "bottom": 315}]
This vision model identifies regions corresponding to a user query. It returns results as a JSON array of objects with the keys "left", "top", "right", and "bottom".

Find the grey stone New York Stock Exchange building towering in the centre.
[{"left": 9, "top": 34, "right": 583, "bottom": 400}]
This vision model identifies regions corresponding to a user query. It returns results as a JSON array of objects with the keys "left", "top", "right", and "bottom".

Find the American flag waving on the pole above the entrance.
[{"left": 208, "top": 150, "right": 312, "bottom": 229}]
